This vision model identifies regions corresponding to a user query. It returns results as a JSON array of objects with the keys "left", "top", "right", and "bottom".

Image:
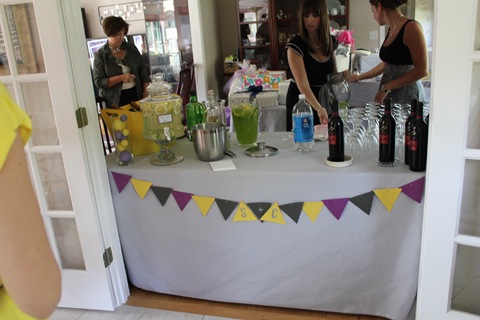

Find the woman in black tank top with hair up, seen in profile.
[{"left": 347, "top": 0, "right": 428, "bottom": 103}]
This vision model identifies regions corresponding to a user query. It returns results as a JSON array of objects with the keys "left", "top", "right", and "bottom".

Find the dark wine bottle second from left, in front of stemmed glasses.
[{"left": 378, "top": 97, "right": 396, "bottom": 163}]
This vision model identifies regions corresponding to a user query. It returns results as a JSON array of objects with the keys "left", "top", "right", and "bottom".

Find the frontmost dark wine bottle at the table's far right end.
[{"left": 410, "top": 102, "right": 428, "bottom": 172}]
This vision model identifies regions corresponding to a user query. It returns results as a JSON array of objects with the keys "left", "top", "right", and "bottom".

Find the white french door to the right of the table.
[{"left": 417, "top": 0, "right": 480, "bottom": 320}]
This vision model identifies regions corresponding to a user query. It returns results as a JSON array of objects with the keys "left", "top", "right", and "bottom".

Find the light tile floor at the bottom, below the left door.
[{"left": 49, "top": 305, "right": 235, "bottom": 320}]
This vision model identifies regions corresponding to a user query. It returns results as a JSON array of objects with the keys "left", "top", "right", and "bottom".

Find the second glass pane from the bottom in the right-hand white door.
[{"left": 459, "top": 160, "right": 480, "bottom": 237}]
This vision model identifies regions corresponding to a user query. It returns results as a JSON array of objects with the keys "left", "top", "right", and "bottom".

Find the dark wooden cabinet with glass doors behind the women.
[{"left": 237, "top": 0, "right": 349, "bottom": 75}]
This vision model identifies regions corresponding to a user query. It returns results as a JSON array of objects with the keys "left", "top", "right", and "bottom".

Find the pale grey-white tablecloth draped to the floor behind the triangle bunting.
[{"left": 107, "top": 133, "right": 423, "bottom": 319}]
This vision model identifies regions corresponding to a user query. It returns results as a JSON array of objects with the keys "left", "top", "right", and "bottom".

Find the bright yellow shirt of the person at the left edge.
[{"left": 0, "top": 82, "right": 40, "bottom": 320}]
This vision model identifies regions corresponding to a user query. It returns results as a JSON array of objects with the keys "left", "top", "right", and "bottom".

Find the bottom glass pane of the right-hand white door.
[{"left": 452, "top": 245, "right": 480, "bottom": 315}]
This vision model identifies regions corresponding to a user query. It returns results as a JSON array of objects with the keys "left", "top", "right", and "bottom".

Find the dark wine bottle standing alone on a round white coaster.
[{"left": 328, "top": 99, "right": 345, "bottom": 162}]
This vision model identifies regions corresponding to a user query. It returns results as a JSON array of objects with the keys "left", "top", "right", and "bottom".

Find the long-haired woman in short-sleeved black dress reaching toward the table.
[{"left": 286, "top": 0, "right": 338, "bottom": 131}]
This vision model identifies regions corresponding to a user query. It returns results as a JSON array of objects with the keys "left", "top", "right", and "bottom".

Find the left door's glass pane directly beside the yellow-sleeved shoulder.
[{"left": 21, "top": 81, "right": 59, "bottom": 146}]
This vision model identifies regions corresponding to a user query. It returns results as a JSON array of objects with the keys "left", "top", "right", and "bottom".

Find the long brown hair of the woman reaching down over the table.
[{"left": 298, "top": 0, "right": 334, "bottom": 57}]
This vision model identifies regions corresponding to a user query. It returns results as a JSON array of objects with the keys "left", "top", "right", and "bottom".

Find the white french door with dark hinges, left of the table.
[{"left": 0, "top": 0, "right": 128, "bottom": 310}]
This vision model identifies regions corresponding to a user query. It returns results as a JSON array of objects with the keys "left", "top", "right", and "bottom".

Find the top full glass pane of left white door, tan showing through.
[{"left": 5, "top": 3, "right": 45, "bottom": 74}]
